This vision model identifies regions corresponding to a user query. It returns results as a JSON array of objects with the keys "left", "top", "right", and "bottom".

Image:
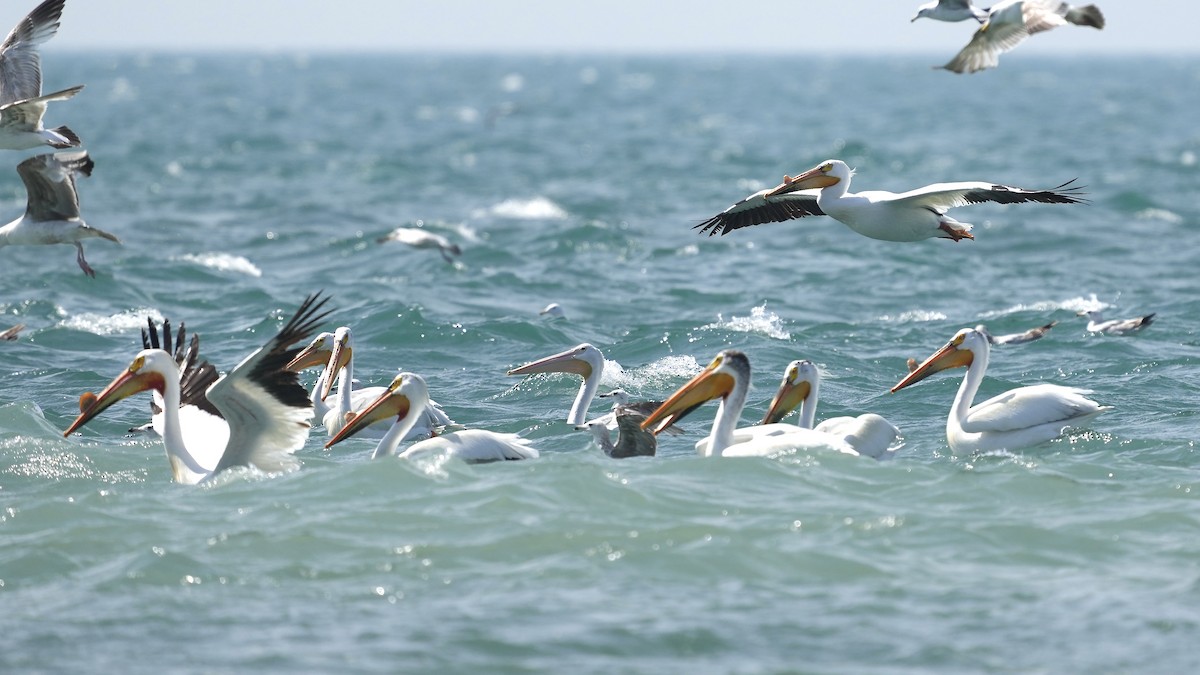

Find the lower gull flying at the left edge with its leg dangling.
[{"left": 0, "top": 150, "right": 121, "bottom": 277}]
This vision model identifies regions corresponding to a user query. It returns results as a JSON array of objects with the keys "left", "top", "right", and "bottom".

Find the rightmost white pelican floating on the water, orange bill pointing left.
[{"left": 892, "top": 328, "right": 1111, "bottom": 452}]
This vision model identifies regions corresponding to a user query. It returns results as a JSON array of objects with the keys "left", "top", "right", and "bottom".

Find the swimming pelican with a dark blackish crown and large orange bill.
[{"left": 642, "top": 350, "right": 858, "bottom": 456}]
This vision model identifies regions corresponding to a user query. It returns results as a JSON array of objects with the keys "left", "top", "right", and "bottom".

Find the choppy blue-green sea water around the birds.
[{"left": 0, "top": 53, "right": 1200, "bottom": 674}]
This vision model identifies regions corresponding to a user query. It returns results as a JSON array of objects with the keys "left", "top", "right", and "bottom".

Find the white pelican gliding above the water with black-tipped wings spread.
[{"left": 696, "top": 160, "right": 1084, "bottom": 241}]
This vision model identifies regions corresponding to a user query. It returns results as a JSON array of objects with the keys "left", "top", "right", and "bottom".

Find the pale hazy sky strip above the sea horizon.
[{"left": 30, "top": 0, "right": 1200, "bottom": 54}]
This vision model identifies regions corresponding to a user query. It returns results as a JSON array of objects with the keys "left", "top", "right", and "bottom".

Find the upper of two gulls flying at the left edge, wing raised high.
[{"left": 0, "top": 0, "right": 83, "bottom": 150}]
